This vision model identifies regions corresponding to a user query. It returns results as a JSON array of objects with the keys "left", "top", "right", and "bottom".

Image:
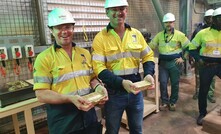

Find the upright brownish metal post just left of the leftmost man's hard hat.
[{"left": 35, "top": 0, "right": 46, "bottom": 45}]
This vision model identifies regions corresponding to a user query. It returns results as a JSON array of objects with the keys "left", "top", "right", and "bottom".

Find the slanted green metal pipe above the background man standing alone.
[{"left": 152, "top": 0, "right": 164, "bottom": 28}]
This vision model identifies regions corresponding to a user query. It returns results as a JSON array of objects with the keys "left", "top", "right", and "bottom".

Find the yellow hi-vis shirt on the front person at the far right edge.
[{"left": 189, "top": 27, "right": 221, "bottom": 58}]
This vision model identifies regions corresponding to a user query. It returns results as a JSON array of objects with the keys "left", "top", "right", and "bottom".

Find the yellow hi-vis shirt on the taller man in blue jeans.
[{"left": 92, "top": 28, "right": 154, "bottom": 75}]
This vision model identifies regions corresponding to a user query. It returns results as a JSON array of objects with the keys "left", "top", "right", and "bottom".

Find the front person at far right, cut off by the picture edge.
[{"left": 189, "top": 7, "right": 221, "bottom": 125}]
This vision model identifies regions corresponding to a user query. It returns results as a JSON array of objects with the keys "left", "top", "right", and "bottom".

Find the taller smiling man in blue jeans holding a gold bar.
[{"left": 92, "top": 0, "right": 154, "bottom": 134}]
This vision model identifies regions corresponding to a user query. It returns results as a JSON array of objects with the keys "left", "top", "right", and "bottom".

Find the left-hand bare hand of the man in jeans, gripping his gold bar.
[{"left": 122, "top": 80, "right": 140, "bottom": 94}]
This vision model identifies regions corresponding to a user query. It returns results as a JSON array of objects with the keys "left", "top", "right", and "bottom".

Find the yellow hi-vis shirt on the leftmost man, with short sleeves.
[{"left": 34, "top": 45, "right": 93, "bottom": 95}]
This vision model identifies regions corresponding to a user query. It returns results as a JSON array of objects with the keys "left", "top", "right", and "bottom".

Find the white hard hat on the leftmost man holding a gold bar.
[{"left": 48, "top": 8, "right": 75, "bottom": 27}]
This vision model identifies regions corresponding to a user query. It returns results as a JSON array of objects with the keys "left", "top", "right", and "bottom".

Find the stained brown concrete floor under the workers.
[{"left": 36, "top": 76, "right": 221, "bottom": 134}]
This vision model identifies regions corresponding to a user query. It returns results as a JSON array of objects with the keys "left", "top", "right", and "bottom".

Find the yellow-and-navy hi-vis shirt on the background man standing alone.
[{"left": 149, "top": 29, "right": 190, "bottom": 60}]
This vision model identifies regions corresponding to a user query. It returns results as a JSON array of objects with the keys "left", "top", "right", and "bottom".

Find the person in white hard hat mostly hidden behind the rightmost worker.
[{"left": 190, "top": 9, "right": 216, "bottom": 103}]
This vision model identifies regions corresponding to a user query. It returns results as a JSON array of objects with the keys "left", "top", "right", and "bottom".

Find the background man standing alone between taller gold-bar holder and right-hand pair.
[{"left": 149, "top": 13, "right": 190, "bottom": 111}]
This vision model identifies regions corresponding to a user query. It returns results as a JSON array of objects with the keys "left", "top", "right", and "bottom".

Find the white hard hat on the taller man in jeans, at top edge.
[{"left": 104, "top": 0, "right": 128, "bottom": 8}]
